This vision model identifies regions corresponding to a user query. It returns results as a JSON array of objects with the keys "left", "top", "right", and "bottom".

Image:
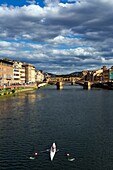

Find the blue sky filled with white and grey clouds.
[{"left": 0, "top": 0, "right": 113, "bottom": 74}]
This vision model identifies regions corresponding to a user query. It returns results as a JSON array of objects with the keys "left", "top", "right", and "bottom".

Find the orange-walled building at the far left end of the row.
[{"left": 0, "top": 59, "right": 13, "bottom": 86}]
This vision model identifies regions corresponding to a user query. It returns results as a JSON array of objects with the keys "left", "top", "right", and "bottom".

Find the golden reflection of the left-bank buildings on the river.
[{"left": 0, "top": 91, "right": 47, "bottom": 119}]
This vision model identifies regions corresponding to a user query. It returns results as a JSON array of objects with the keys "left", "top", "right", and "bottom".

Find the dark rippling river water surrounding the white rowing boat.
[{"left": 0, "top": 85, "right": 113, "bottom": 170}]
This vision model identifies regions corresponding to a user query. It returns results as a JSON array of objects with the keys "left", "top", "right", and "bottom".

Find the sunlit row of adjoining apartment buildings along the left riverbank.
[{"left": 0, "top": 59, "right": 45, "bottom": 86}]
